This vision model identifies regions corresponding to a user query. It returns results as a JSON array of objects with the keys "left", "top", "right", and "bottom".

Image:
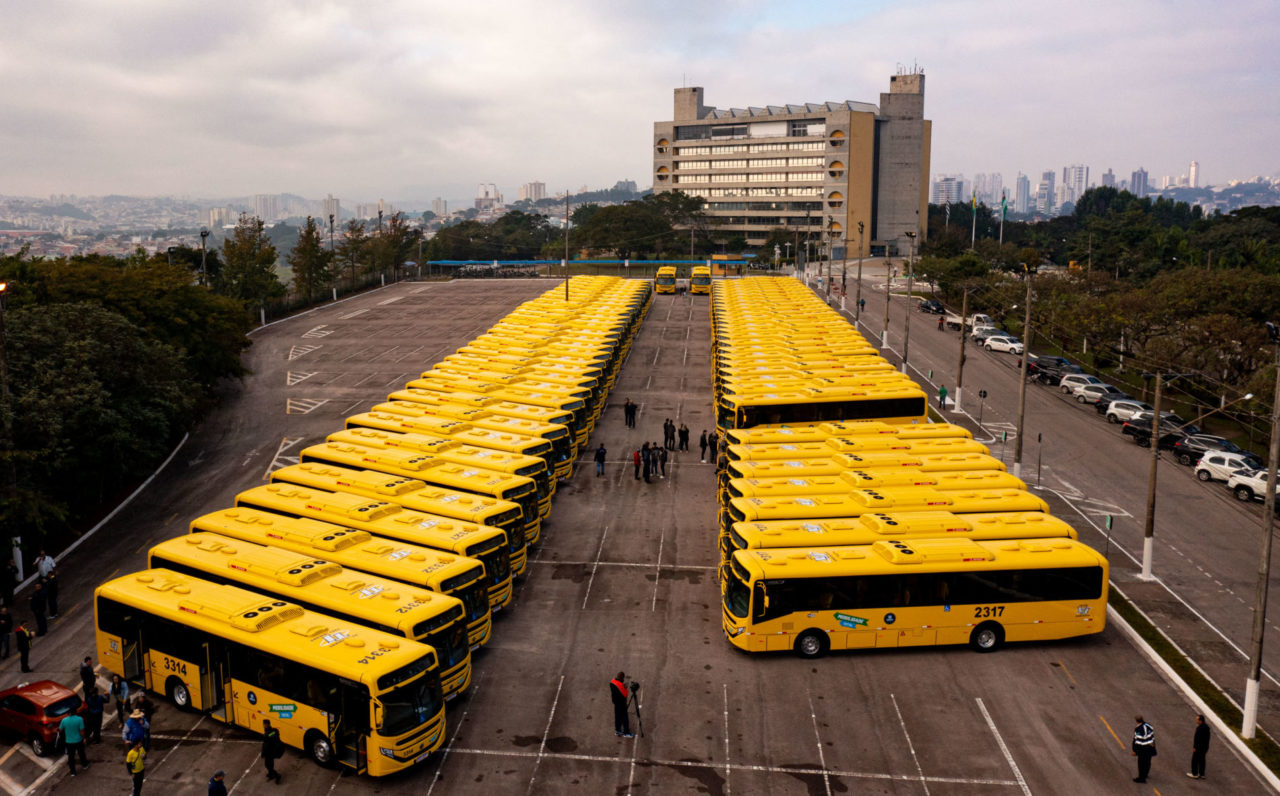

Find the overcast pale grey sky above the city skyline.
[{"left": 0, "top": 0, "right": 1280, "bottom": 207}]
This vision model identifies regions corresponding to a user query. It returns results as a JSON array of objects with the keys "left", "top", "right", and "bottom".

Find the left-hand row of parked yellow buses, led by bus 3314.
[{"left": 95, "top": 276, "right": 652, "bottom": 776}]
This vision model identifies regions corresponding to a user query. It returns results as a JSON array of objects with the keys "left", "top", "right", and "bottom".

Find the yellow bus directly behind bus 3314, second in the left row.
[{"left": 147, "top": 534, "right": 471, "bottom": 700}]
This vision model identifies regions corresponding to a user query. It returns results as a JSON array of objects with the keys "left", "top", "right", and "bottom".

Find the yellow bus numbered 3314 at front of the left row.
[{"left": 93, "top": 569, "right": 444, "bottom": 777}]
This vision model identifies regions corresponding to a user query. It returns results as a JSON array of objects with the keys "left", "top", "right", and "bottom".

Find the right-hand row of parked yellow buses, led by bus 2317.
[{"left": 710, "top": 278, "right": 1107, "bottom": 657}]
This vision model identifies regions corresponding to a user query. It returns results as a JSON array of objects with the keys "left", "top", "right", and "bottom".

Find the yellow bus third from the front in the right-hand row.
[{"left": 721, "top": 486, "right": 1048, "bottom": 535}]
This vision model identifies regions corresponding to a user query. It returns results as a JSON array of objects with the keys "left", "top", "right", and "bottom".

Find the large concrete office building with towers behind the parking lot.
[{"left": 653, "top": 70, "right": 932, "bottom": 259}]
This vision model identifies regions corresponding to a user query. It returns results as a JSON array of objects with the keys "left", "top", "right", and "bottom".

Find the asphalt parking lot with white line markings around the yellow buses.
[{"left": 12, "top": 280, "right": 1266, "bottom": 795}]
